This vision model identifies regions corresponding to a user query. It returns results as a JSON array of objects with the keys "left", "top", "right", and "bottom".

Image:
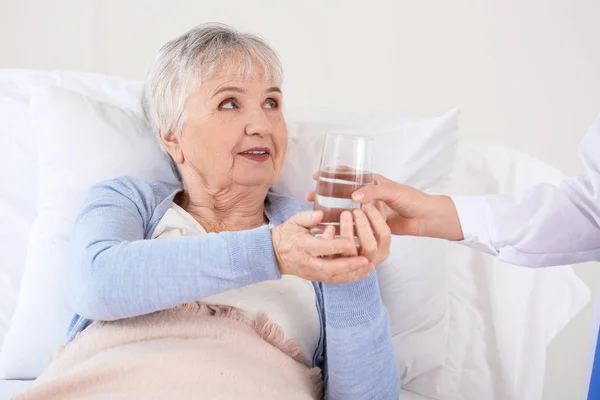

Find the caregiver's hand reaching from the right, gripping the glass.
[{"left": 306, "top": 174, "right": 463, "bottom": 240}]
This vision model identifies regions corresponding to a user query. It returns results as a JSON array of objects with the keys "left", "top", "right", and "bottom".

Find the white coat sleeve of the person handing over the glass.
[{"left": 453, "top": 117, "right": 600, "bottom": 267}]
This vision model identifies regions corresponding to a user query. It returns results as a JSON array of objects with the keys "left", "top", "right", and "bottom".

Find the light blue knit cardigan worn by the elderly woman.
[{"left": 66, "top": 177, "right": 400, "bottom": 400}]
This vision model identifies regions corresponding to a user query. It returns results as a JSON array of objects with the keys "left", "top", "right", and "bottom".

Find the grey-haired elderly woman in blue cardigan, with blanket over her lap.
[{"left": 21, "top": 25, "right": 400, "bottom": 400}]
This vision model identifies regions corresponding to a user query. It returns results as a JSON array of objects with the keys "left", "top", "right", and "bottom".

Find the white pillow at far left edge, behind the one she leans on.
[{"left": 0, "top": 70, "right": 142, "bottom": 347}]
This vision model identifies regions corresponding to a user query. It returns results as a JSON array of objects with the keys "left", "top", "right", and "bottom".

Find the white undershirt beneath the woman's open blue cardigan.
[{"left": 152, "top": 203, "right": 320, "bottom": 366}]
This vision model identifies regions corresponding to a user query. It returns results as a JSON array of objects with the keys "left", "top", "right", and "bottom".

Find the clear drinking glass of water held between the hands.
[{"left": 311, "top": 134, "right": 373, "bottom": 242}]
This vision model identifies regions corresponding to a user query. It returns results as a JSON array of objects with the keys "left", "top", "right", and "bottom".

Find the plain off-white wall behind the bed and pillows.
[{"left": 0, "top": 0, "right": 600, "bottom": 400}]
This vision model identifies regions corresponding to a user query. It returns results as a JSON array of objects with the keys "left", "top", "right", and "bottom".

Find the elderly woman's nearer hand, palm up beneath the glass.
[{"left": 271, "top": 211, "right": 375, "bottom": 283}]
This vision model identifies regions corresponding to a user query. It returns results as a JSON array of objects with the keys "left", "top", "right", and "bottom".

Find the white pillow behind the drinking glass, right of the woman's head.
[{"left": 274, "top": 108, "right": 459, "bottom": 383}]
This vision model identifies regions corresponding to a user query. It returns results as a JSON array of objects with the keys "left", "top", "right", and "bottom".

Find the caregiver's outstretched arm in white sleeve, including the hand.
[{"left": 354, "top": 118, "right": 600, "bottom": 267}]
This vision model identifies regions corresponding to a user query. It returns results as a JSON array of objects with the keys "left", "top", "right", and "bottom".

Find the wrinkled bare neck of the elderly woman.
[{"left": 175, "top": 180, "right": 268, "bottom": 232}]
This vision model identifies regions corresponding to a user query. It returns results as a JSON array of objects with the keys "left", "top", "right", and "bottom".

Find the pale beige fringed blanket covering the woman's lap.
[{"left": 15, "top": 302, "right": 322, "bottom": 400}]
